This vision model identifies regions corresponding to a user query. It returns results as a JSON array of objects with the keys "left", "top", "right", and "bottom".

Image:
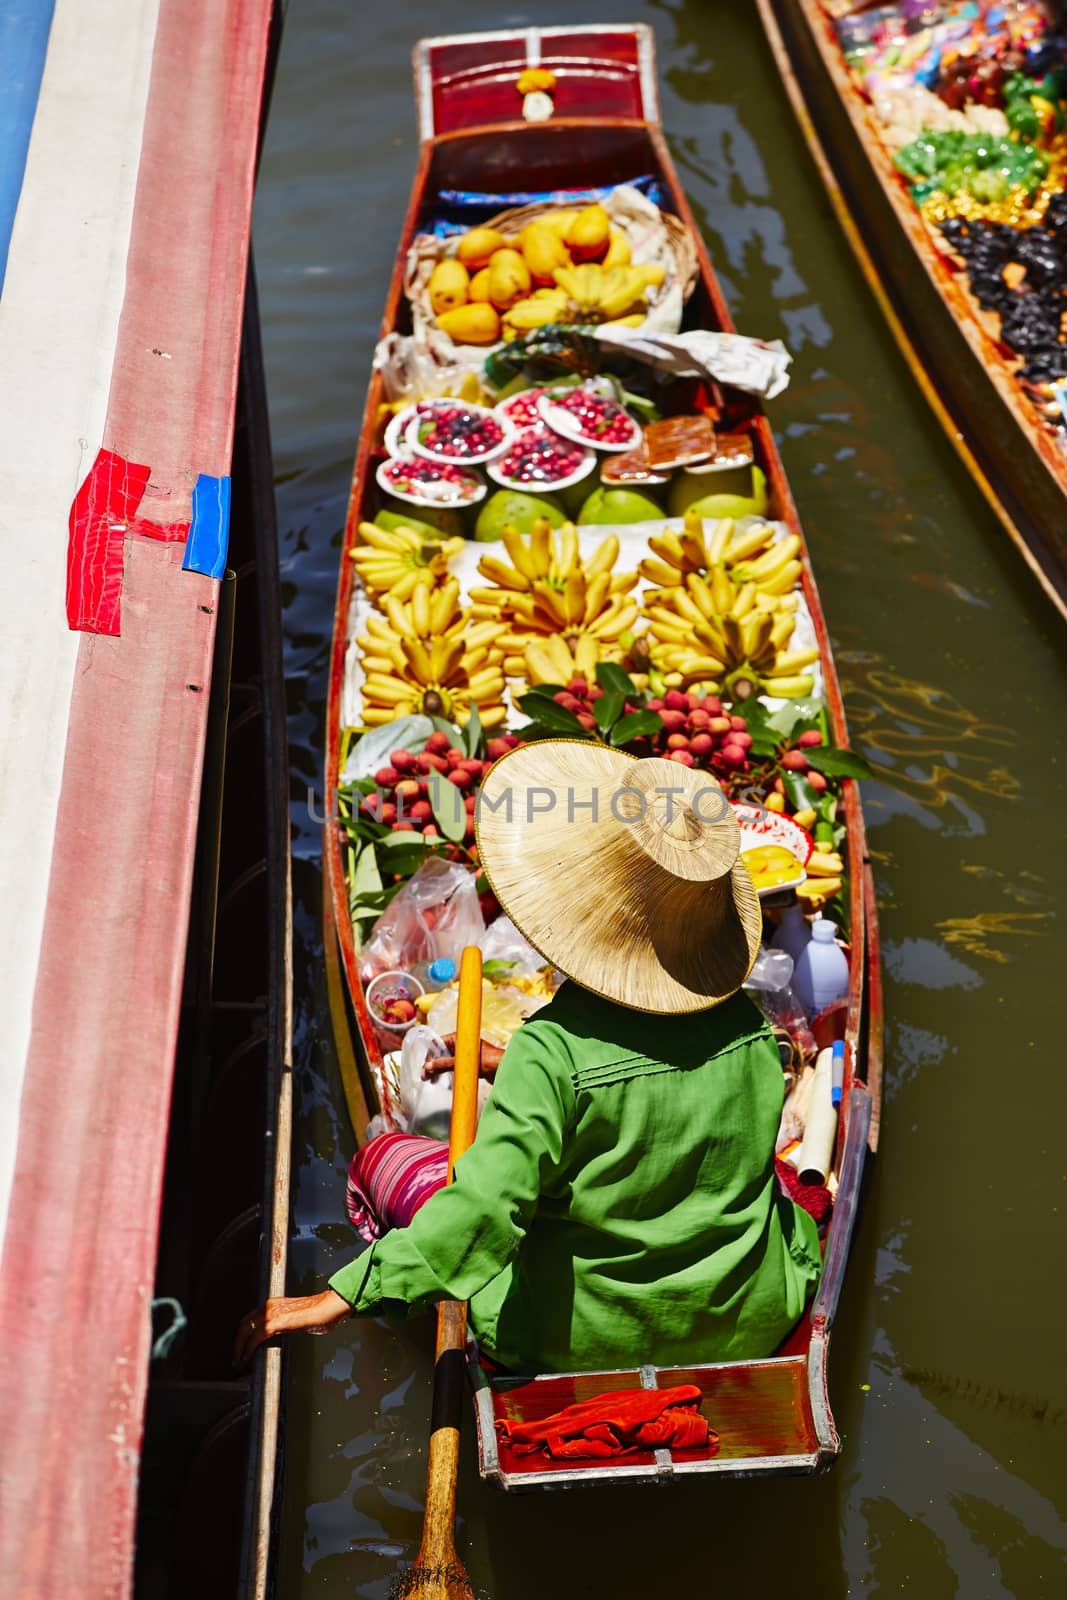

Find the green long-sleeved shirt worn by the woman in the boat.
[{"left": 330, "top": 982, "right": 821, "bottom": 1373}]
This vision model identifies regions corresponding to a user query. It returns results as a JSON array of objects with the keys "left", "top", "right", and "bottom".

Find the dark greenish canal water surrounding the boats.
[{"left": 256, "top": 0, "right": 1067, "bottom": 1600}]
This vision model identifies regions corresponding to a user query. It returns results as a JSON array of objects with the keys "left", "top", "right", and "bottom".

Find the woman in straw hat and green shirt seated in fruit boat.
[{"left": 237, "top": 739, "right": 821, "bottom": 1373}]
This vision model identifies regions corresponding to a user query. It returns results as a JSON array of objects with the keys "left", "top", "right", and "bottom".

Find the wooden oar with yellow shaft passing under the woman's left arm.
[{"left": 394, "top": 946, "right": 482, "bottom": 1600}]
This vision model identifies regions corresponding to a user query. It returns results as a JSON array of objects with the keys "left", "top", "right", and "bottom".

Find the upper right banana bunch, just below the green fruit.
[{"left": 640, "top": 510, "right": 803, "bottom": 610}]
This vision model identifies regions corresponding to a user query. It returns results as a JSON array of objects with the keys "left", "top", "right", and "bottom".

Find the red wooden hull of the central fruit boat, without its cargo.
[{"left": 323, "top": 26, "right": 881, "bottom": 1490}]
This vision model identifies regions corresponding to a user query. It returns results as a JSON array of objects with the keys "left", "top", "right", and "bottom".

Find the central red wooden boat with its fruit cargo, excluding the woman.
[{"left": 323, "top": 27, "right": 881, "bottom": 1490}]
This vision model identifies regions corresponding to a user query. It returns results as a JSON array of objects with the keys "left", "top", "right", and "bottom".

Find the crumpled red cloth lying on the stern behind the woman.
[{"left": 496, "top": 1384, "right": 718, "bottom": 1461}]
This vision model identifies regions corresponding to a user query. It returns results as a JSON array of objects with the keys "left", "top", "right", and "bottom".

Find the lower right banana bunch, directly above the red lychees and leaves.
[{"left": 645, "top": 568, "right": 819, "bottom": 699}]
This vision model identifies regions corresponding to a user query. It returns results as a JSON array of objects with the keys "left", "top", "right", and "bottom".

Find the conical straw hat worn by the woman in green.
[{"left": 475, "top": 739, "right": 761, "bottom": 1013}]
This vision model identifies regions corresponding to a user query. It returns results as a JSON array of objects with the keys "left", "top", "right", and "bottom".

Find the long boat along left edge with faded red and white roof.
[{"left": 0, "top": 0, "right": 291, "bottom": 1600}]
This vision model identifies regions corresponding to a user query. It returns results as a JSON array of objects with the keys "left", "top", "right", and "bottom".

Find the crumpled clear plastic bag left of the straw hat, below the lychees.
[{"left": 360, "top": 856, "right": 485, "bottom": 982}]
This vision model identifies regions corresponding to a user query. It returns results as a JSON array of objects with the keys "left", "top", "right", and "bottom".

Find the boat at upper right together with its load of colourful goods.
[{"left": 758, "top": 0, "right": 1067, "bottom": 614}]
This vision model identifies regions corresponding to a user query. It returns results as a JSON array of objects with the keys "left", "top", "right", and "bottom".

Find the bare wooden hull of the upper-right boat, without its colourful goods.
[{"left": 757, "top": 0, "right": 1067, "bottom": 616}]
